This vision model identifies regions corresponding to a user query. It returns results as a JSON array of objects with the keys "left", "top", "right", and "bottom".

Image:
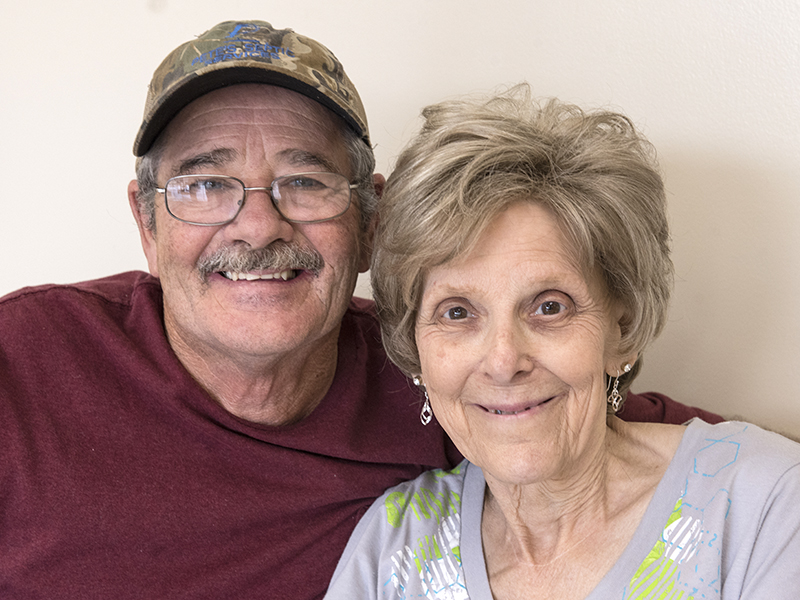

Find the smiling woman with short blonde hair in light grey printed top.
[{"left": 327, "top": 87, "right": 800, "bottom": 600}]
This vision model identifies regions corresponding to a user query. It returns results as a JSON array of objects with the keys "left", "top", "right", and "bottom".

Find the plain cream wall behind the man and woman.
[{"left": 0, "top": 0, "right": 800, "bottom": 435}]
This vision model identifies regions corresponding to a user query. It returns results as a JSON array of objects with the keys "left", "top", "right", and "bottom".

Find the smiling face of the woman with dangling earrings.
[{"left": 416, "top": 201, "right": 623, "bottom": 484}]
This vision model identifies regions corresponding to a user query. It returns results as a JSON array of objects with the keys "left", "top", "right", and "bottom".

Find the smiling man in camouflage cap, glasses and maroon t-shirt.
[{"left": 0, "top": 22, "right": 713, "bottom": 599}]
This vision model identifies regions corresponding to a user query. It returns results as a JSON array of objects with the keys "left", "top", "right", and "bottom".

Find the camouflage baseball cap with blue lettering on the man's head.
[{"left": 133, "top": 21, "right": 369, "bottom": 156}]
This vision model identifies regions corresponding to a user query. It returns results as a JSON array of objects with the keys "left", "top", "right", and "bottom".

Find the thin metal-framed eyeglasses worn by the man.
[{"left": 156, "top": 173, "right": 358, "bottom": 226}]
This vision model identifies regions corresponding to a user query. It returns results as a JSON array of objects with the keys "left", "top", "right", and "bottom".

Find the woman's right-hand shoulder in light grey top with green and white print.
[{"left": 623, "top": 419, "right": 800, "bottom": 598}]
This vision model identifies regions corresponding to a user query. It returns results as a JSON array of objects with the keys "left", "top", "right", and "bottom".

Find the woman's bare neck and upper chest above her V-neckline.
[{"left": 481, "top": 418, "right": 683, "bottom": 600}]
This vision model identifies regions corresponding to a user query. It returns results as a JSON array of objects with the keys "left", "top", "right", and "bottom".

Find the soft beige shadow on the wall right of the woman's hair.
[{"left": 635, "top": 151, "right": 800, "bottom": 436}]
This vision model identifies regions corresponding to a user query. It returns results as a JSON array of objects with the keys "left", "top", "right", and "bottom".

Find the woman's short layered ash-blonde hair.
[{"left": 371, "top": 84, "right": 673, "bottom": 392}]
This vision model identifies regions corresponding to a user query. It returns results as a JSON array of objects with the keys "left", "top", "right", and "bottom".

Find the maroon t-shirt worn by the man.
[{"left": 0, "top": 272, "right": 719, "bottom": 600}]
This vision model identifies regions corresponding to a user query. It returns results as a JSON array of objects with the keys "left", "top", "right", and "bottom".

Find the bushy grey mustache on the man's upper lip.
[{"left": 197, "top": 242, "right": 325, "bottom": 279}]
